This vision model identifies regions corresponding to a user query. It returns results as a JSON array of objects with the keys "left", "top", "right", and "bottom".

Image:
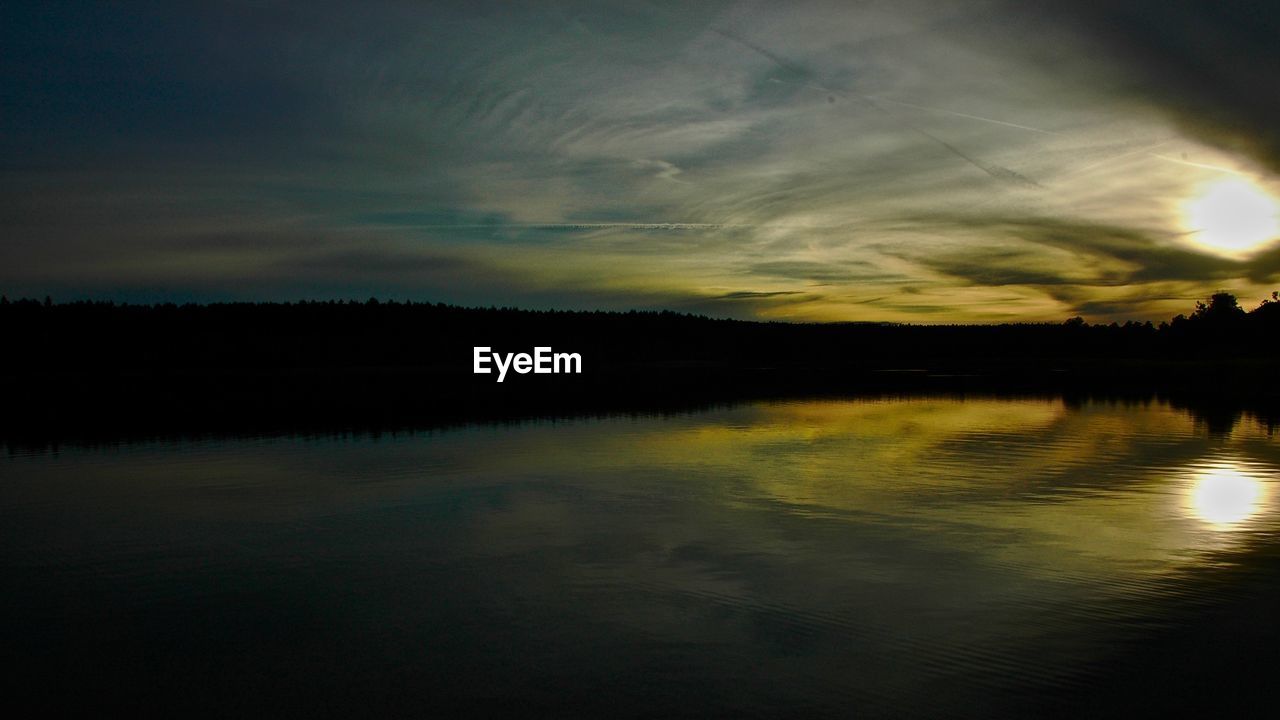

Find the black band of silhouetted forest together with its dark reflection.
[{"left": 0, "top": 292, "right": 1280, "bottom": 436}]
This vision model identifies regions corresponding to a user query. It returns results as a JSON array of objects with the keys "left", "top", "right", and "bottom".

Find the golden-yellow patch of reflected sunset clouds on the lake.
[{"left": 586, "top": 398, "right": 1267, "bottom": 593}]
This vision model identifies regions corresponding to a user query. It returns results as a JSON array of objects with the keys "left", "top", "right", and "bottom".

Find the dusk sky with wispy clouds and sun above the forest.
[{"left": 0, "top": 0, "right": 1280, "bottom": 323}]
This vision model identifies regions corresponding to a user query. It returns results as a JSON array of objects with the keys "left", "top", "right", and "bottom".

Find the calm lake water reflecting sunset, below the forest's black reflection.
[{"left": 0, "top": 400, "right": 1280, "bottom": 716}]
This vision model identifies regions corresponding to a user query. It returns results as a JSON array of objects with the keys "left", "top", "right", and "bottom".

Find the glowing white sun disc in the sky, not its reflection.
[{"left": 1184, "top": 178, "right": 1280, "bottom": 255}]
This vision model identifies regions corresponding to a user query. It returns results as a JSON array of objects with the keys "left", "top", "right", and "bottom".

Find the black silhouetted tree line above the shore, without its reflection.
[{"left": 0, "top": 292, "right": 1280, "bottom": 373}]
